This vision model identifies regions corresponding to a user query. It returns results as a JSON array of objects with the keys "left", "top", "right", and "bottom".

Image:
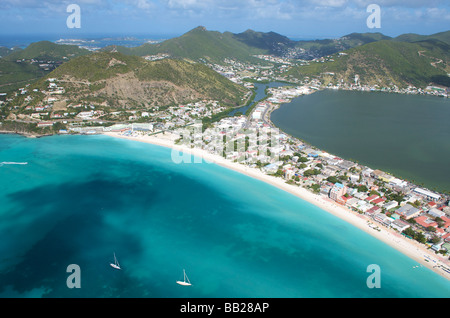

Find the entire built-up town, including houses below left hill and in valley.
[{"left": 0, "top": 52, "right": 450, "bottom": 274}]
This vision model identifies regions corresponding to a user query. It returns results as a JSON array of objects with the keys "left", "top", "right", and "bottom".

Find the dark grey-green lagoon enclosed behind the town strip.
[{"left": 271, "top": 90, "right": 450, "bottom": 192}]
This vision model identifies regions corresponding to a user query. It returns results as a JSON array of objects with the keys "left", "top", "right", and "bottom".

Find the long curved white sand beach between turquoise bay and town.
[{"left": 104, "top": 132, "right": 450, "bottom": 280}]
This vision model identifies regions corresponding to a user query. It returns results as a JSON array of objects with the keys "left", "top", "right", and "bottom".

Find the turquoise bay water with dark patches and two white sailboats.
[{"left": 0, "top": 135, "right": 450, "bottom": 298}]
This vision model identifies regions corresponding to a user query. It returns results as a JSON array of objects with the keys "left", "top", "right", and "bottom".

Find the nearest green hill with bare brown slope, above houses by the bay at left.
[{"left": 27, "top": 52, "right": 247, "bottom": 108}]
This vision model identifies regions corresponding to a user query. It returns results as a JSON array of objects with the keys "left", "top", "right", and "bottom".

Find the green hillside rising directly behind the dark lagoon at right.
[{"left": 289, "top": 40, "right": 450, "bottom": 87}]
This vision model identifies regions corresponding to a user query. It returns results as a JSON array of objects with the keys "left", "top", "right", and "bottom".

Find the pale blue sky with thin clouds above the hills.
[{"left": 0, "top": 0, "right": 450, "bottom": 39}]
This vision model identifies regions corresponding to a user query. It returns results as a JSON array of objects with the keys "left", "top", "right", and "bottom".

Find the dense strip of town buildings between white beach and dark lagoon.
[{"left": 106, "top": 87, "right": 450, "bottom": 275}]
